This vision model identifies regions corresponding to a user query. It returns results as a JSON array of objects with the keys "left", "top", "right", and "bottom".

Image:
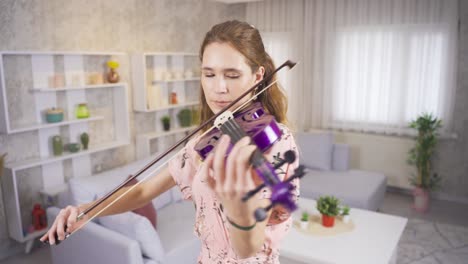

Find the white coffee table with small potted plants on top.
[{"left": 280, "top": 198, "right": 407, "bottom": 264}]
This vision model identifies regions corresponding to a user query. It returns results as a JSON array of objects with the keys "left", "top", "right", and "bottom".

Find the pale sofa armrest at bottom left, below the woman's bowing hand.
[{"left": 47, "top": 207, "right": 143, "bottom": 264}]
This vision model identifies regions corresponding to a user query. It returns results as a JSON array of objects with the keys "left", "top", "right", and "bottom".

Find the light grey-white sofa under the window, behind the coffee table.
[{"left": 296, "top": 132, "right": 387, "bottom": 211}]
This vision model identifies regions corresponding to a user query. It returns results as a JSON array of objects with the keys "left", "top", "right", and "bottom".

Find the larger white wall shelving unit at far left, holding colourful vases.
[{"left": 0, "top": 51, "right": 130, "bottom": 242}]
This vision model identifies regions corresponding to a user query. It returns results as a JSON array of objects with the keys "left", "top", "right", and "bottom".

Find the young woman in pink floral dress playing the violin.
[{"left": 41, "top": 21, "right": 298, "bottom": 263}]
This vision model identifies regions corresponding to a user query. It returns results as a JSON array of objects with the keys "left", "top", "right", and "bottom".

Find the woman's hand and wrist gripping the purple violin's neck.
[{"left": 202, "top": 135, "right": 260, "bottom": 226}]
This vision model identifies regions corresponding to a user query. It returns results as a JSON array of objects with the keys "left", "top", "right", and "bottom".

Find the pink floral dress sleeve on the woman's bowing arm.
[{"left": 169, "top": 141, "right": 198, "bottom": 200}]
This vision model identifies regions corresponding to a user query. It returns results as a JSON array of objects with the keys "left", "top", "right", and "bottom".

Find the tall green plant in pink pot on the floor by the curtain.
[{"left": 408, "top": 113, "right": 442, "bottom": 212}]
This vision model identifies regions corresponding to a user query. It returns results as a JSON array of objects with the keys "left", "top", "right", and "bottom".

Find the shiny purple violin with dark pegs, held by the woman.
[{"left": 195, "top": 102, "right": 304, "bottom": 221}]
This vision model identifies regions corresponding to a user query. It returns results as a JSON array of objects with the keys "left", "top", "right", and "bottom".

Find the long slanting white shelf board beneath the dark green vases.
[{"left": 5, "top": 141, "right": 129, "bottom": 170}]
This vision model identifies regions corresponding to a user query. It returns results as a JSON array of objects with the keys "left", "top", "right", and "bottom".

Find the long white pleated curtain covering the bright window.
[{"left": 247, "top": 0, "right": 458, "bottom": 134}]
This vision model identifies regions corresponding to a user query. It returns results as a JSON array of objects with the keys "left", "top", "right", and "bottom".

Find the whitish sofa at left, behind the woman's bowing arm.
[{"left": 47, "top": 159, "right": 200, "bottom": 264}]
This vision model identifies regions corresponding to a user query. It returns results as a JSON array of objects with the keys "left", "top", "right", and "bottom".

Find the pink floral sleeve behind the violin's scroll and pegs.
[{"left": 260, "top": 125, "right": 299, "bottom": 225}]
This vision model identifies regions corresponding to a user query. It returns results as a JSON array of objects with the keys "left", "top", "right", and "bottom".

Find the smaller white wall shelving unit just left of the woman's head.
[{"left": 131, "top": 52, "right": 200, "bottom": 159}]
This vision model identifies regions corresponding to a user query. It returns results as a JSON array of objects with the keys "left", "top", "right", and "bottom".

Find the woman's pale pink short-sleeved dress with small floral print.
[{"left": 169, "top": 125, "right": 299, "bottom": 264}]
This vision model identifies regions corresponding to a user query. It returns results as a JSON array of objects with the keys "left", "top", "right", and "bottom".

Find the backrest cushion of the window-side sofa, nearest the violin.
[{"left": 296, "top": 132, "right": 333, "bottom": 171}]
